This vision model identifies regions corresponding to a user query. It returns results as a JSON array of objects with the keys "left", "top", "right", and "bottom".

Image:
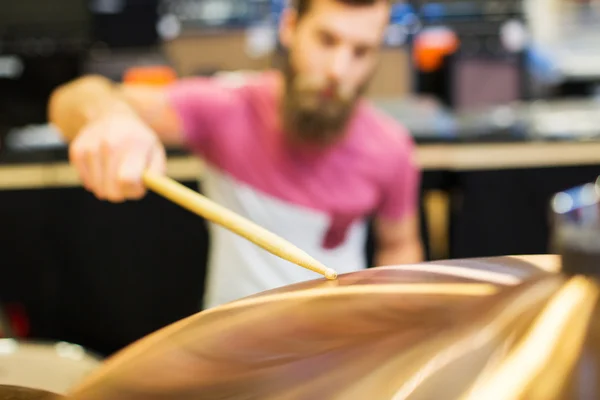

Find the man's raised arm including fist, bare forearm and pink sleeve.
[{"left": 48, "top": 72, "right": 243, "bottom": 202}]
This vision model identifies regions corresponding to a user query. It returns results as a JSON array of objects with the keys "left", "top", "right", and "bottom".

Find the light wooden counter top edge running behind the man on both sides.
[{"left": 0, "top": 141, "right": 600, "bottom": 190}]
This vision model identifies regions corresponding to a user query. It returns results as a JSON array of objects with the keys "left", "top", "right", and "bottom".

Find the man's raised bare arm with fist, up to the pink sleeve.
[{"left": 48, "top": 76, "right": 183, "bottom": 202}]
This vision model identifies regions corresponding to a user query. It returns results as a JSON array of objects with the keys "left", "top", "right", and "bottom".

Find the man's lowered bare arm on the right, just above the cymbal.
[{"left": 374, "top": 214, "right": 424, "bottom": 267}]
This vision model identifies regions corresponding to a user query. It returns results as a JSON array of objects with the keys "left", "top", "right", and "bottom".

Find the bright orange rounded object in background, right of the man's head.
[{"left": 413, "top": 28, "right": 460, "bottom": 72}]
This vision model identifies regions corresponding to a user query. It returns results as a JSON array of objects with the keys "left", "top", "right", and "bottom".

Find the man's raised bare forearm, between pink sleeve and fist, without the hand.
[{"left": 48, "top": 75, "right": 183, "bottom": 145}]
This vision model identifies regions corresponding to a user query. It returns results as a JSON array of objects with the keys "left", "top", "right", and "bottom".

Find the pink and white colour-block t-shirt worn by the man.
[{"left": 170, "top": 72, "right": 420, "bottom": 307}]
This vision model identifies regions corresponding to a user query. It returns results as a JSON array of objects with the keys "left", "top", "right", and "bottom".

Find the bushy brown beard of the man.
[{"left": 282, "top": 55, "right": 370, "bottom": 146}]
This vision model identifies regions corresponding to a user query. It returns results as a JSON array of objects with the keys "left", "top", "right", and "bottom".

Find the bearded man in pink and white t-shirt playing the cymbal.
[{"left": 49, "top": 0, "right": 422, "bottom": 308}]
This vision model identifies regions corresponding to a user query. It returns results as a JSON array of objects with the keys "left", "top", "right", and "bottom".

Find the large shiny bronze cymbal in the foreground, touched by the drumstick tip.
[{"left": 61, "top": 256, "right": 600, "bottom": 400}]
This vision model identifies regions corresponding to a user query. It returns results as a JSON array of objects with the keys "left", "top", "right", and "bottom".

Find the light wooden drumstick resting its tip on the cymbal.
[{"left": 143, "top": 171, "right": 337, "bottom": 280}]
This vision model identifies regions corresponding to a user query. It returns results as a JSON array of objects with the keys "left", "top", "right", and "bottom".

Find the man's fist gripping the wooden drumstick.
[{"left": 69, "top": 105, "right": 166, "bottom": 203}]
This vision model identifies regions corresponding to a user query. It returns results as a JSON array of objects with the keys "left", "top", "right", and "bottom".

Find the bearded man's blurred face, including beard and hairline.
[{"left": 281, "top": 0, "right": 389, "bottom": 144}]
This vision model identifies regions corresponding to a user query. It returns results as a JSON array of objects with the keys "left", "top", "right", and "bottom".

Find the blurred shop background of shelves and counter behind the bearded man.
[{"left": 0, "top": 0, "right": 600, "bottom": 355}]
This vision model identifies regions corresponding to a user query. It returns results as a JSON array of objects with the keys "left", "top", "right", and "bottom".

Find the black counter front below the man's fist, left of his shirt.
[{"left": 0, "top": 183, "right": 208, "bottom": 354}]
